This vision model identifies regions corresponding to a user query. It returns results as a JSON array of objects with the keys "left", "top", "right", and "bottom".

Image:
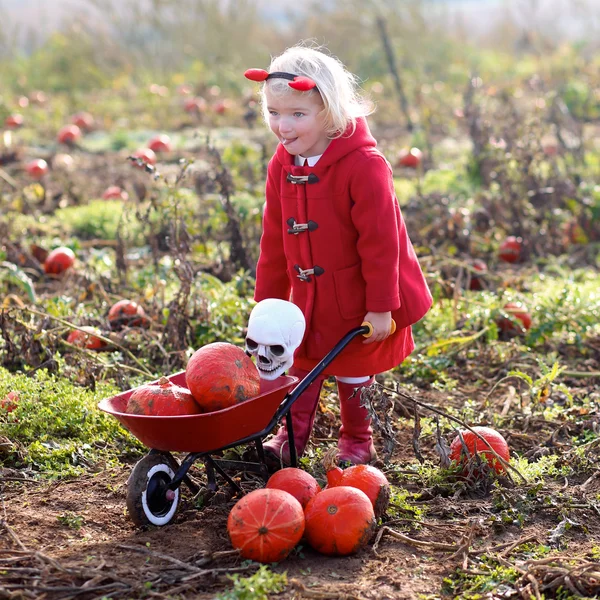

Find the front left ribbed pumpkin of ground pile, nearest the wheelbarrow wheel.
[{"left": 227, "top": 488, "right": 304, "bottom": 563}]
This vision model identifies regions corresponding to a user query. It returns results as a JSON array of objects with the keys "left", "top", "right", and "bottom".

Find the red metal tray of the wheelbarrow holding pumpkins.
[{"left": 98, "top": 371, "right": 298, "bottom": 452}]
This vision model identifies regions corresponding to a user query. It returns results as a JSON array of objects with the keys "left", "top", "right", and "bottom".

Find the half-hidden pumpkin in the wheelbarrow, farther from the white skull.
[{"left": 125, "top": 377, "right": 202, "bottom": 417}]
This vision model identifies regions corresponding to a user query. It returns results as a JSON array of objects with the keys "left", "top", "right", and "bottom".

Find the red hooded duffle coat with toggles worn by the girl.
[{"left": 254, "top": 119, "right": 432, "bottom": 377}]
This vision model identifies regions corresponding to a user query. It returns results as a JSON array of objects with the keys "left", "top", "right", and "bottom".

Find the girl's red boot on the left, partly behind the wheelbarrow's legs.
[{"left": 263, "top": 367, "right": 325, "bottom": 468}]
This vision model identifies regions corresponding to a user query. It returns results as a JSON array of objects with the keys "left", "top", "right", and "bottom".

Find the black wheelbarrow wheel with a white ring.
[{"left": 127, "top": 454, "right": 179, "bottom": 527}]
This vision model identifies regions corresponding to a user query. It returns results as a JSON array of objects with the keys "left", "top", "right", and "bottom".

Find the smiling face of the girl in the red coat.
[{"left": 265, "top": 87, "right": 331, "bottom": 157}]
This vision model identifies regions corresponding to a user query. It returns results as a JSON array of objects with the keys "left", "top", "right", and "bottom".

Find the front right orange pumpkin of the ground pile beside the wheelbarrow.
[{"left": 304, "top": 485, "right": 376, "bottom": 556}]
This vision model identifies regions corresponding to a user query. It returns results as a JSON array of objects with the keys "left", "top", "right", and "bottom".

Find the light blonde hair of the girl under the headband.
[{"left": 261, "top": 44, "right": 375, "bottom": 139}]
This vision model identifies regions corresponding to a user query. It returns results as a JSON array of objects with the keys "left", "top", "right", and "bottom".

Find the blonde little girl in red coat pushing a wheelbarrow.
[{"left": 245, "top": 46, "right": 432, "bottom": 464}]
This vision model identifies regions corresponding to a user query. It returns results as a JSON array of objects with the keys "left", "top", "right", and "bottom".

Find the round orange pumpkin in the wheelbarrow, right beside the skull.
[{"left": 185, "top": 342, "right": 260, "bottom": 412}]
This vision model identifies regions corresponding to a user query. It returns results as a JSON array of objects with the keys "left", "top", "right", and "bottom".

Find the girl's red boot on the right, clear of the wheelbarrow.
[{"left": 337, "top": 377, "right": 377, "bottom": 465}]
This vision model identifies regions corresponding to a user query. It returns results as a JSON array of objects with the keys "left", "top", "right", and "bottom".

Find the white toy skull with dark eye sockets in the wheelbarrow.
[{"left": 246, "top": 298, "right": 306, "bottom": 380}]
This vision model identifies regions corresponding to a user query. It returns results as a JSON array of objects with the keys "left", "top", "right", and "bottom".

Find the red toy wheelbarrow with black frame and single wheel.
[{"left": 98, "top": 323, "right": 380, "bottom": 526}]
